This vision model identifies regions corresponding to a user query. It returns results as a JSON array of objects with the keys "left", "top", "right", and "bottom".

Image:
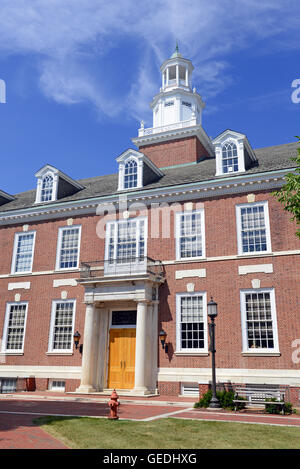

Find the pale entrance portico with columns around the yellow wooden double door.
[{"left": 76, "top": 260, "right": 164, "bottom": 395}]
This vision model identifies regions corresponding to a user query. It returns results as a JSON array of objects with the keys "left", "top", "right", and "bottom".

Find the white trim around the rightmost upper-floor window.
[{"left": 235, "top": 200, "right": 272, "bottom": 257}]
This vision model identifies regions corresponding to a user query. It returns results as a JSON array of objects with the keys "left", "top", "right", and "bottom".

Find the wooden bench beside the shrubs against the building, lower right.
[{"left": 233, "top": 385, "right": 284, "bottom": 413}]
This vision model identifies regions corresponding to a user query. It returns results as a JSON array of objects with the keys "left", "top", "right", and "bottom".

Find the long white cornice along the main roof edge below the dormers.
[{"left": 0, "top": 168, "right": 291, "bottom": 225}]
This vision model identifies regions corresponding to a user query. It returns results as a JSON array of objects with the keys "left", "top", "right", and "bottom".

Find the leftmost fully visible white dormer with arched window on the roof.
[{"left": 35, "top": 164, "right": 83, "bottom": 203}]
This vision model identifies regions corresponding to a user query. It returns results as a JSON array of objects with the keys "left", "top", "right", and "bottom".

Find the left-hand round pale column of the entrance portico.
[{"left": 76, "top": 303, "right": 99, "bottom": 392}]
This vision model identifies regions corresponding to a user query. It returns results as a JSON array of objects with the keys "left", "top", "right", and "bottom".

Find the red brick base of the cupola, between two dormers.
[{"left": 139, "top": 137, "right": 209, "bottom": 168}]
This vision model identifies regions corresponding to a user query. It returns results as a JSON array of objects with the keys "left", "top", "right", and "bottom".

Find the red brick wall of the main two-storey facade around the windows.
[{"left": 0, "top": 188, "right": 300, "bottom": 392}]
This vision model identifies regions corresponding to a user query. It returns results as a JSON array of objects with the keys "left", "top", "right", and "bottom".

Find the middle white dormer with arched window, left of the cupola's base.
[{"left": 117, "top": 148, "right": 163, "bottom": 191}]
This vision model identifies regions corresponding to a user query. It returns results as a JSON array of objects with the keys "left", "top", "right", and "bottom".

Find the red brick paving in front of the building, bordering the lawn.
[{"left": 0, "top": 394, "right": 300, "bottom": 449}]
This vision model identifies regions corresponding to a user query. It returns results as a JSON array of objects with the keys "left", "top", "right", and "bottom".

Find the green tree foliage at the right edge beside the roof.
[{"left": 274, "top": 137, "right": 300, "bottom": 238}]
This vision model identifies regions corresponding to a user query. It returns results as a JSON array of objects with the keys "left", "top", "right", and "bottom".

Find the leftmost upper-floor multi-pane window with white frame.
[{"left": 12, "top": 232, "right": 35, "bottom": 273}]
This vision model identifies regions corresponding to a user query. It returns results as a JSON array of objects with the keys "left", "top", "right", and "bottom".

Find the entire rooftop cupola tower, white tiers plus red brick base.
[{"left": 132, "top": 44, "right": 214, "bottom": 162}]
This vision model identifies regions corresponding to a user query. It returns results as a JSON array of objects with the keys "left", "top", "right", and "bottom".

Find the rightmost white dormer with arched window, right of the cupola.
[{"left": 212, "top": 129, "right": 258, "bottom": 176}]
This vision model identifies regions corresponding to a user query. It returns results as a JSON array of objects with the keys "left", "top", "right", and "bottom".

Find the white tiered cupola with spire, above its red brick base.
[{"left": 150, "top": 44, "right": 205, "bottom": 133}]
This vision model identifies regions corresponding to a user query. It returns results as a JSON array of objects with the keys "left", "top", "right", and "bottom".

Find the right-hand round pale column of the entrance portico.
[{"left": 133, "top": 301, "right": 148, "bottom": 394}]
